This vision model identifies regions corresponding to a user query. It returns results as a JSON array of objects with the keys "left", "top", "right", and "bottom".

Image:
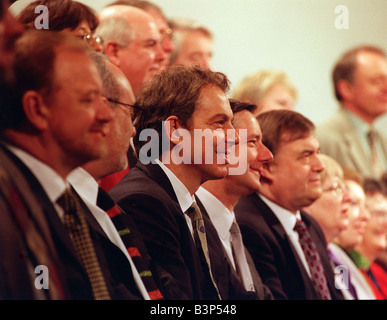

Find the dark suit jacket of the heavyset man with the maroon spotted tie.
[{"left": 234, "top": 193, "right": 343, "bottom": 300}]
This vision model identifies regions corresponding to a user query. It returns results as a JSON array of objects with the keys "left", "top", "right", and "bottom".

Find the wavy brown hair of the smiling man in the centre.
[{"left": 134, "top": 66, "right": 229, "bottom": 149}]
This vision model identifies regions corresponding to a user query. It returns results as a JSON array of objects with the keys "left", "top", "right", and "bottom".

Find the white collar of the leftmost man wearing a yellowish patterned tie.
[{"left": 7, "top": 144, "right": 67, "bottom": 203}]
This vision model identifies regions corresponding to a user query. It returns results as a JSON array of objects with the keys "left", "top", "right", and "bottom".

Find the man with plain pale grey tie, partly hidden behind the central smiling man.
[{"left": 199, "top": 100, "right": 273, "bottom": 300}]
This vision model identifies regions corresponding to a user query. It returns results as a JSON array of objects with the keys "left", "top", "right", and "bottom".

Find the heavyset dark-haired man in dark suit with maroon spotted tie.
[{"left": 235, "top": 110, "right": 341, "bottom": 299}]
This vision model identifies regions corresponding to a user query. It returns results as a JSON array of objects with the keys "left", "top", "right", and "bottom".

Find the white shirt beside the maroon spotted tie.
[{"left": 258, "top": 194, "right": 311, "bottom": 277}]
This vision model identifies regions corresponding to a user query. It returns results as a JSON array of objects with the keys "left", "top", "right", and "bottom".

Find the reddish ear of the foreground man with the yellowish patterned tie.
[{"left": 22, "top": 90, "right": 50, "bottom": 131}]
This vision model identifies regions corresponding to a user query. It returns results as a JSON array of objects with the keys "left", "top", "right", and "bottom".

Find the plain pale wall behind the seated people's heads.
[{"left": 9, "top": 0, "right": 387, "bottom": 130}]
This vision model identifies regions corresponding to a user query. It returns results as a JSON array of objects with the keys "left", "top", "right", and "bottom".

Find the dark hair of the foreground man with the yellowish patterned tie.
[{"left": 0, "top": 30, "right": 91, "bottom": 130}]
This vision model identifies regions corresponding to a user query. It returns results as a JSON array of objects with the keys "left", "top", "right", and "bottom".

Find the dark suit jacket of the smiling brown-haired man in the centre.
[{"left": 109, "top": 162, "right": 256, "bottom": 300}]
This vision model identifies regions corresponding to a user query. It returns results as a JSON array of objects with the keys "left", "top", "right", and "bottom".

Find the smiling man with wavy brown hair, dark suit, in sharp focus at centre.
[{"left": 110, "top": 66, "right": 256, "bottom": 299}]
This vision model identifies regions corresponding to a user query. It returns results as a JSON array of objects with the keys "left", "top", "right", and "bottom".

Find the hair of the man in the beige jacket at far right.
[{"left": 332, "top": 45, "right": 386, "bottom": 101}]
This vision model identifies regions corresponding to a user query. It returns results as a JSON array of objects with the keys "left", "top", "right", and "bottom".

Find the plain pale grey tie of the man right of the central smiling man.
[{"left": 230, "top": 221, "right": 255, "bottom": 291}]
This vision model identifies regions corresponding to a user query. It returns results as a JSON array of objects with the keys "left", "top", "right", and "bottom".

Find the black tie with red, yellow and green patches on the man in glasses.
[{"left": 97, "top": 188, "right": 164, "bottom": 300}]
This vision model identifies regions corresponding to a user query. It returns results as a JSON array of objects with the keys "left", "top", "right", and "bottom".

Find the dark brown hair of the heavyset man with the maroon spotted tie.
[{"left": 257, "top": 110, "right": 315, "bottom": 155}]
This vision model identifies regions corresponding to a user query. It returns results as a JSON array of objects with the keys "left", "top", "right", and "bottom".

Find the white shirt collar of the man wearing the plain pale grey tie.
[{"left": 196, "top": 187, "right": 235, "bottom": 240}]
